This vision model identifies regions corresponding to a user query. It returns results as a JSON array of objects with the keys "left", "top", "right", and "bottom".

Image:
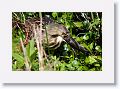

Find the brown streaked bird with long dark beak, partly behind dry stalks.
[{"left": 13, "top": 16, "right": 89, "bottom": 55}]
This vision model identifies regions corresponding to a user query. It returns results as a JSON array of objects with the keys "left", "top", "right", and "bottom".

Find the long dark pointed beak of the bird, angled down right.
[{"left": 64, "top": 36, "right": 89, "bottom": 55}]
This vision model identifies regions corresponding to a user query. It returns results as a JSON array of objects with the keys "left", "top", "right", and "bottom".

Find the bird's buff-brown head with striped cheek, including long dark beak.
[{"left": 44, "top": 23, "right": 88, "bottom": 54}]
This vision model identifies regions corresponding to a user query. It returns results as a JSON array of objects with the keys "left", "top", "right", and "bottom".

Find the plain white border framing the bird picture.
[{"left": 0, "top": 0, "right": 114, "bottom": 83}]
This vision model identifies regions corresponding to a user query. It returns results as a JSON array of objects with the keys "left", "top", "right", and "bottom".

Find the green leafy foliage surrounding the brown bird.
[{"left": 12, "top": 12, "right": 102, "bottom": 71}]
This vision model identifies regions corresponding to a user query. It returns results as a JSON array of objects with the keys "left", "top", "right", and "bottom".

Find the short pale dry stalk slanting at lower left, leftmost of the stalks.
[{"left": 20, "top": 38, "right": 31, "bottom": 71}]
